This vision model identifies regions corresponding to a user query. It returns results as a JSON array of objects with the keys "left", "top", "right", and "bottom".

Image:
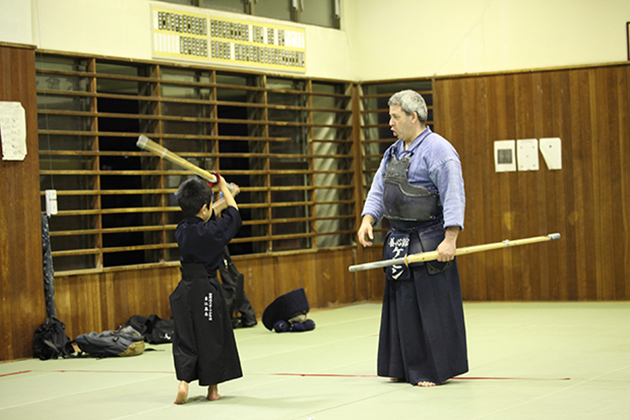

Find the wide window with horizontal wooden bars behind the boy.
[{"left": 36, "top": 53, "right": 355, "bottom": 272}]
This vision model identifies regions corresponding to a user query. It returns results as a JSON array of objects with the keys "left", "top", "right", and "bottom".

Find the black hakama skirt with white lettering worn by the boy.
[{"left": 170, "top": 264, "right": 243, "bottom": 386}]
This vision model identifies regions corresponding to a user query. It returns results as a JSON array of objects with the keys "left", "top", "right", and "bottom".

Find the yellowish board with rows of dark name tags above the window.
[{"left": 151, "top": 5, "right": 306, "bottom": 73}]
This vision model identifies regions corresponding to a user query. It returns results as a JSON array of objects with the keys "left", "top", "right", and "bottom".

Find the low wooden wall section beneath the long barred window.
[{"left": 55, "top": 248, "right": 383, "bottom": 338}]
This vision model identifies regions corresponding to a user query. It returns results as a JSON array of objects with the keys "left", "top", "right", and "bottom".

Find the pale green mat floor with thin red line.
[{"left": 0, "top": 302, "right": 630, "bottom": 420}]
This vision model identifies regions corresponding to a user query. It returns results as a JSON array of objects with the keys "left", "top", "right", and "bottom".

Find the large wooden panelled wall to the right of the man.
[{"left": 434, "top": 65, "right": 630, "bottom": 301}]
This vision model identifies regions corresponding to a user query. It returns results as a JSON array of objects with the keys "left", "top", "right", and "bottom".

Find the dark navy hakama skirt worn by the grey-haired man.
[{"left": 378, "top": 221, "right": 468, "bottom": 384}]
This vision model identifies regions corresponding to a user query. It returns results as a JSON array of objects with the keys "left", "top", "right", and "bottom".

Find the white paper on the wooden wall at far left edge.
[{"left": 0, "top": 101, "right": 26, "bottom": 160}]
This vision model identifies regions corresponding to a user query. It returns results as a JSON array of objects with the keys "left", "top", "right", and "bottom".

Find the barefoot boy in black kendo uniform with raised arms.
[{"left": 170, "top": 174, "right": 243, "bottom": 404}]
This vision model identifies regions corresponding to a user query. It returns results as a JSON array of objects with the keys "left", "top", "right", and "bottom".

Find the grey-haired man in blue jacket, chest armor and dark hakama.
[{"left": 357, "top": 90, "right": 468, "bottom": 387}]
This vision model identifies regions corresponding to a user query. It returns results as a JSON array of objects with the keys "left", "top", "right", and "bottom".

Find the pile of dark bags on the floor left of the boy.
[{"left": 33, "top": 314, "right": 175, "bottom": 360}]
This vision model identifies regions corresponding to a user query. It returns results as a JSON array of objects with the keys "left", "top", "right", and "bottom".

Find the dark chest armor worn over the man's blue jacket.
[{"left": 383, "top": 154, "right": 440, "bottom": 222}]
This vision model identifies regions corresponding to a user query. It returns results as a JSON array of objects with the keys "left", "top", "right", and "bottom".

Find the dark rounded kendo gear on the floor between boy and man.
[{"left": 262, "top": 287, "right": 315, "bottom": 332}]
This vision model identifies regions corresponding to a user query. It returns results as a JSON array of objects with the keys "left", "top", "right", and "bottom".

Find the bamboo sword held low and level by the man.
[{"left": 349, "top": 233, "right": 560, "bottom": 272}]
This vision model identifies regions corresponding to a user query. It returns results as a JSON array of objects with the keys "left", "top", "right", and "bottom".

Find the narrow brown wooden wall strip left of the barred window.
[{"left": 0, "top": 44, "right": 46, "bottom": 360}]
